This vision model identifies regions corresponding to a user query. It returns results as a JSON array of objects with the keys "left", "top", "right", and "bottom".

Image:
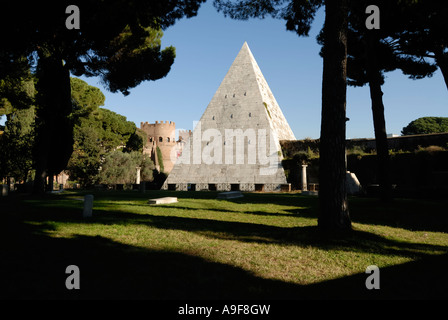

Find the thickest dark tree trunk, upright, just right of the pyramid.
[{"left": 318, "top": 0, "right": 351, "bottom": 231}]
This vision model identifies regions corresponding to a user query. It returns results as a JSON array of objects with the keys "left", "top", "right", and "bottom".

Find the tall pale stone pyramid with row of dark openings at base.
[{"left": 162, "top": 43, "right": 295, "bottom": 191}]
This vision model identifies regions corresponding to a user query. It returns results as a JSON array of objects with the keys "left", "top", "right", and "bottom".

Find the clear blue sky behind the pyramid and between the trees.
[{"left": 62, "top": 1, "right": 448, "bottom": 139}]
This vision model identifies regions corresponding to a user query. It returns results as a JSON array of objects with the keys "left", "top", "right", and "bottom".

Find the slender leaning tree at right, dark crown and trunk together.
[{"left": 318, "top": 0, "right": 437, "bottom": 201}]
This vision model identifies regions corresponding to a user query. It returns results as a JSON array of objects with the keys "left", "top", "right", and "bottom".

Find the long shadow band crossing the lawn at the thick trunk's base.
[{"left": 7, "top": 195, "right": 448, "bottom": 257}]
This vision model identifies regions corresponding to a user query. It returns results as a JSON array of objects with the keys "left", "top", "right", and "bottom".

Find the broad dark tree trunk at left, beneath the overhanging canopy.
[{"left": 34, "top": 50, "right": 73, "bottom": 193}]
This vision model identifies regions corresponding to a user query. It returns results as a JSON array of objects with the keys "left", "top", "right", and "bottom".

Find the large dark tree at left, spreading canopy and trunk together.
[{"left": 0, "top": 0, "right": 205, "bottom": 192}]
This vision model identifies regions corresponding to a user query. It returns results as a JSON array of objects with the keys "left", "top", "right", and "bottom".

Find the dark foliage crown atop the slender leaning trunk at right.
[{"left": 344, "top": 0, "right": 437, "bottom": 86}]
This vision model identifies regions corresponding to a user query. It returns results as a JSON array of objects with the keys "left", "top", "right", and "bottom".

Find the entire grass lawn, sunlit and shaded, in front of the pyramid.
[{"left": 0, "top": 191, "right": 448, "bottom": 299}]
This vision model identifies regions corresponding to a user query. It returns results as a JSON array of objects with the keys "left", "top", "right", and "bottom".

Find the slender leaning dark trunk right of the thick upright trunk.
[{"left": 366, "top": 34, "right": 392, "bottom": 202}]
